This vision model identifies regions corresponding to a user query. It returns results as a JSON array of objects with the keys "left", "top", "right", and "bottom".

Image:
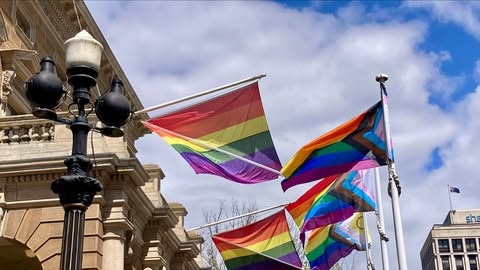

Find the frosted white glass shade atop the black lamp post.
[{"left": 65, "top": 30, "right": 103, "bottom": 71}]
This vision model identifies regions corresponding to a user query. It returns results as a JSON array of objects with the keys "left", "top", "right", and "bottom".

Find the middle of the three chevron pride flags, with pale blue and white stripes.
[{"left": 286, "top": 170, "right": 376, "bottom": 233}]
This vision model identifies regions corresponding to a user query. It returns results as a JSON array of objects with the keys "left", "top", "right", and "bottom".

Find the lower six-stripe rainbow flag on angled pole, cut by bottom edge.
[{"left": 212, "top": 209, "right": 302, "bottom": 270}]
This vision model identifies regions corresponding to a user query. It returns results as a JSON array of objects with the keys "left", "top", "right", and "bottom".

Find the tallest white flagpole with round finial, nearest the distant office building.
[{"left": 375, "top": 74, "right": 407, "bottom": 270}]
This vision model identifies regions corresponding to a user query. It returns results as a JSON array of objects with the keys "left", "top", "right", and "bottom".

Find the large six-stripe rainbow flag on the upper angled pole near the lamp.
[{"left": 145, "top": 83, "right": 281, "bottom": 184}]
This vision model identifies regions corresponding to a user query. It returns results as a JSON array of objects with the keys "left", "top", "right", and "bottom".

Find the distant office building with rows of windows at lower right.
[{"left": 420, "top": 209, "right": 480, "bottom": 270}]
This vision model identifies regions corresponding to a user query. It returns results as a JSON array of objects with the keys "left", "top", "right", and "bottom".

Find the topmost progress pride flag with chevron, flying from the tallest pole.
[{"left": 281, "top": 102, "right": 393, "bottom": 191}]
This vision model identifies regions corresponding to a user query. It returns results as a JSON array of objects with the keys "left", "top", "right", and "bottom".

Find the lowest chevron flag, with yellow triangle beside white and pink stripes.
[{"left": 305, "top": 213, "right": 366, "bottom": 270}]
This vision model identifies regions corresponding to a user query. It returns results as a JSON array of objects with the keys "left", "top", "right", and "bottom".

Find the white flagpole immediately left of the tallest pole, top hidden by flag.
[{"left": 374, "top": 167, "right": 390, "bottom": 270}]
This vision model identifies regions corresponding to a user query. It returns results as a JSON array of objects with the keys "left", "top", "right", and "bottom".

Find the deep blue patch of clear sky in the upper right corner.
[{"left": 284, "top": 0, "right": 480, "bottom": 110}]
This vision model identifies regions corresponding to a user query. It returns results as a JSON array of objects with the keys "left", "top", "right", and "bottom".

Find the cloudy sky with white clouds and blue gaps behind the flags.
[{"left": 87, "top": 0, "right": 480, "bottom": 269}]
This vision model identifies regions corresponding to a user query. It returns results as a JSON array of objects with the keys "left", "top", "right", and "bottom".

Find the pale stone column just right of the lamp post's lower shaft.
[{"left": 102, "top": 224, "right": 125, "bottom": 270}]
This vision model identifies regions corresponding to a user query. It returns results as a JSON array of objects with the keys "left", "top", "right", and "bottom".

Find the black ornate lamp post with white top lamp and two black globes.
[{"left": 25, "top": 30, "right": 131, "bottom": 270}]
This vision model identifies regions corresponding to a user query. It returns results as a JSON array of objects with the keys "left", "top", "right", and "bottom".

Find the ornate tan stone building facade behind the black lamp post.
[{"left": 0, "top": 0, "right": 203, "bottom": 270}]
